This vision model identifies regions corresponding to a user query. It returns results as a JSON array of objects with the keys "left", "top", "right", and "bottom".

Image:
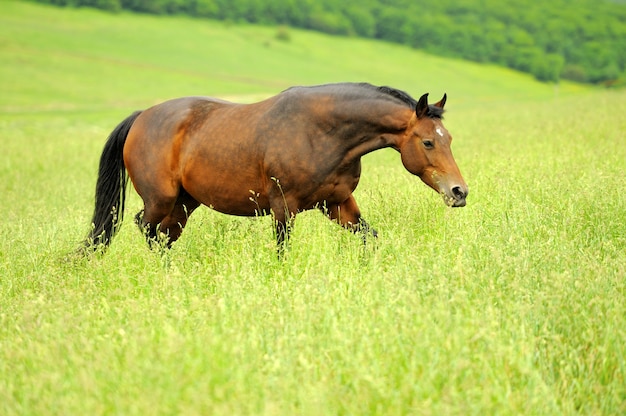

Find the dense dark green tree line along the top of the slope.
[{"left": 29, "top": 0, "right": 626, "bottom": 85}]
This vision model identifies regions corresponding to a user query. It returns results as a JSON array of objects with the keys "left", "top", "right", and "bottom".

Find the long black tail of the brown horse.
[{"left": 85, "top": 111, "right": 141, "bottom": 250}]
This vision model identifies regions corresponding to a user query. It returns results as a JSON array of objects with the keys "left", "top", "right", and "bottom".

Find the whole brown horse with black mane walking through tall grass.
[{"left": 85, "top": 83, "right": 468, "bottom": 248}]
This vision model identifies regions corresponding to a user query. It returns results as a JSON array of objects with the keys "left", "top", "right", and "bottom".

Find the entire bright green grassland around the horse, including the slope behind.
[{"left": 0, "top": 1, "right": 626, "bottom": 415}]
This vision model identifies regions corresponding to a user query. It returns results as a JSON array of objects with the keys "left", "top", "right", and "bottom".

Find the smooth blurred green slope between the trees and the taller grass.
[{"left": 0, "top": 1, "right": 584, "bottom": 118}]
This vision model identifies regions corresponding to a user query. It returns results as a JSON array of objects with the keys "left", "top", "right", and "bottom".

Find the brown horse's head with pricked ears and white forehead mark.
[{"left": 398, "top": 94, "right": 469, "bottom": 207}]
